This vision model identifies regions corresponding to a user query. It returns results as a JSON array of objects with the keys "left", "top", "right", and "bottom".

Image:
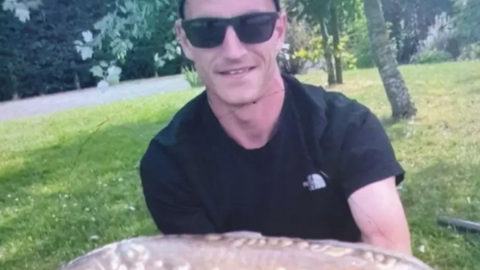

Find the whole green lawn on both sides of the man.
[{"left": 0, "top": 62, "right": 480, "bottom": 270}]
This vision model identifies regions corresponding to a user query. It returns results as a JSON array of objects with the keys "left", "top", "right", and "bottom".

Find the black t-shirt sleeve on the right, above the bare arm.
[{"left": 339, "top": 110, "right": 405, "bottom": 197}]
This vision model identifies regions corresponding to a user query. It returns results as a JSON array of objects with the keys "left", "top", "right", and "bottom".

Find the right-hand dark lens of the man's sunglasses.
[{"left": 235, "top": 13, "right": 277, "bottom": 44}]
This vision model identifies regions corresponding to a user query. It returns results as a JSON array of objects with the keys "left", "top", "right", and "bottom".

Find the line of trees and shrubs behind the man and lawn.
[{"left": 0, "top": 0, "right": 480, "bottom": 117}]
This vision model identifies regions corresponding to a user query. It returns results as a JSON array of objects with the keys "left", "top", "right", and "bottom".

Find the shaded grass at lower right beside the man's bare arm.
[{"left": 401, "top": 160, "right": 480, "bottom": 270}]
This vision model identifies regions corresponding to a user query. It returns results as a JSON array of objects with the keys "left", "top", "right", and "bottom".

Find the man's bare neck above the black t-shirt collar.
[{"left": 210, "top": 75, "right": 285, "bottom": 149}]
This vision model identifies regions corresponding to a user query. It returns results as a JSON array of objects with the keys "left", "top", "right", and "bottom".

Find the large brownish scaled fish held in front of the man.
[{"left": 58, "top": 232, "right": 435, "bottom": 270}]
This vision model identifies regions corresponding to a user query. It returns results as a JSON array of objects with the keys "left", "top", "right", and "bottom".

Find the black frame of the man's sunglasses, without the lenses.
[{"left": 181, "top": 11, "right": 280, "bottom": 48}]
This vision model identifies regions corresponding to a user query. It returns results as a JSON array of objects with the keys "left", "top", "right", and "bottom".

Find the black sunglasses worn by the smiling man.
[{"left": 182, "top": 12, "right": 279, "bottom": 48}]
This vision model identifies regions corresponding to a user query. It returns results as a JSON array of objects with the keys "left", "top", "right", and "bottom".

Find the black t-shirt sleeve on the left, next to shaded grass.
[{"left": 140, "top": 140, "right": 214, "bottom": 234}]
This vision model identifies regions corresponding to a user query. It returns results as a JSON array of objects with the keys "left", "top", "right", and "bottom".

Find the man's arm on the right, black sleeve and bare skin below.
[{"left": 341, "top": 108, "right": 412, "bottom": 254}]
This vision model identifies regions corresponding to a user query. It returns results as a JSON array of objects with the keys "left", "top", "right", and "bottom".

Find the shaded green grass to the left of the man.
[{"left": 0, "top": 119, "right": 177, "bottom": 270}]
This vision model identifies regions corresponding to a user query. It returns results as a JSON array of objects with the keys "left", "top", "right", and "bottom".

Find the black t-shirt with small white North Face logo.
[{"left": 140, "top": 75, "right": 404, "bottom": 241}]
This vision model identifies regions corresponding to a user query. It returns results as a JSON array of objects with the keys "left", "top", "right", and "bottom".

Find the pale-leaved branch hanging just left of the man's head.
[{"left": 75, "top": 0, "right": 181, "bottom": 86}]
